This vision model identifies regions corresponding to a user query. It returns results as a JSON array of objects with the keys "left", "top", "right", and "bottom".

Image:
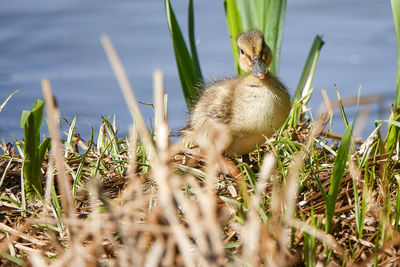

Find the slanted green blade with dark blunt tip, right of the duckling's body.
[{"left": 293, "top": 35, "right": 324, "bottom": 99}]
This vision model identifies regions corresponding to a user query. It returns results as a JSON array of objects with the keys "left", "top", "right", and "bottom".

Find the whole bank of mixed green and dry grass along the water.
[{"left": 0, "top": 0, "right": 400, "bottom": 266}]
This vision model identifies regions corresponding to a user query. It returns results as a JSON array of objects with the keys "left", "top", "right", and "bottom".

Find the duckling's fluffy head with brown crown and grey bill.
[{"left": 236, "top": 29, "right": 272, "bottom": 79}]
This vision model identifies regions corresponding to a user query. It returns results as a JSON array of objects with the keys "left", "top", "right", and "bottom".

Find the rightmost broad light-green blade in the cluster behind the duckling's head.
[{"left": 259, "top": 0, "right": 286, "bottom": 75}]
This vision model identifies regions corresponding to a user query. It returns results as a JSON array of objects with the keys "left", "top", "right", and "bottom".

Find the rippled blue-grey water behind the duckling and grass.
[{"left": 0, "top": 0, "right": 396, "bottom": 141}]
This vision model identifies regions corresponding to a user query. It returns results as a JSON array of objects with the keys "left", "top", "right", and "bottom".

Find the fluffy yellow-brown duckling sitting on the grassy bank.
[{"left": 184, "top": 29, "right": 291, "bottom": 155}]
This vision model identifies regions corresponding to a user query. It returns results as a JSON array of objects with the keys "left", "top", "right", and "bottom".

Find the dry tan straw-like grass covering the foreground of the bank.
[{"left": 0, "top": 120, "right": 400, "bottom": 266}]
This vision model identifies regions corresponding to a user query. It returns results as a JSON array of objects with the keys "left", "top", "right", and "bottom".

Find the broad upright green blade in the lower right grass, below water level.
[{"left": 325, "top": 123, "right": 353, "bottom": 233}]
